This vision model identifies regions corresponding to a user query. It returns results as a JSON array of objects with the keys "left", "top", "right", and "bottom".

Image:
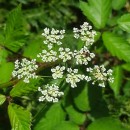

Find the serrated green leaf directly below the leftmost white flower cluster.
[{"left": 10, "top": 79, "right": 39, "bottom": 97}]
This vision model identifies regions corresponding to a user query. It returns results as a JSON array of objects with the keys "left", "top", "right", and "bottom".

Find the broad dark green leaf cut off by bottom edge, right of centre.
[{"left": 87, "top": 117, "right": 127, "bottom": 130}]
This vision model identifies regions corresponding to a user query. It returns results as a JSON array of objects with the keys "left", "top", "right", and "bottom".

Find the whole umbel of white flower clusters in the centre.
[{"left": 12, "top": 22, "right": 114, "bottom": 102}]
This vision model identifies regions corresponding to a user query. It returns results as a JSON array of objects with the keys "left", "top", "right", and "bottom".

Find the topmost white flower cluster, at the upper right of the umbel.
[{"left": 73, "top": 22, "right": 96, "bottom": 46}]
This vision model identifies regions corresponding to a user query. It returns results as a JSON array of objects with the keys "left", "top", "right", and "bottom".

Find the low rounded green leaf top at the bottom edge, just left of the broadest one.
[{"left": 53, "top": 121, "right": 79, "bottom": 130}]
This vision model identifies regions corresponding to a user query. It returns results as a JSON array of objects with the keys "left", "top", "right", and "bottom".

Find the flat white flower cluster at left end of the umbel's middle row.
[{"left": 37, "top": 50, "right": 58, "bottom": 62}]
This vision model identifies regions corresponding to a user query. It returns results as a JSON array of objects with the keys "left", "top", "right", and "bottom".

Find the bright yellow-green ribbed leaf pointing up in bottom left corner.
[{"left": 8, "top": 103, "right": 31, "bottom": 130}]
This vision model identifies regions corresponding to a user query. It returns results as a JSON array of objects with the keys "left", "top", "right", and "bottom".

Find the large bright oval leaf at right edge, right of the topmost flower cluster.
[{"left": 102, "top": 32, "right": 130, "bottom": 62}]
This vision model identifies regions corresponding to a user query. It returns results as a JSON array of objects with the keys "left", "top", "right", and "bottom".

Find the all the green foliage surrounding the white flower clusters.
[{"left": 0, "top": 0, "right": 130, "bottom": 130}]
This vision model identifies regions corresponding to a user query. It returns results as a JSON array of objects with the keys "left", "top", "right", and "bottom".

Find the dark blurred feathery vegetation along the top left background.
[{"left": 0, "top": 0, "right": 83, "bottom": 32}]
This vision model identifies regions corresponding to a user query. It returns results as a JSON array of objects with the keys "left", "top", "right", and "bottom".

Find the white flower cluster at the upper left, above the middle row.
[{"left": 42, "top": 28, "right": 65, "bottom": 49}]
